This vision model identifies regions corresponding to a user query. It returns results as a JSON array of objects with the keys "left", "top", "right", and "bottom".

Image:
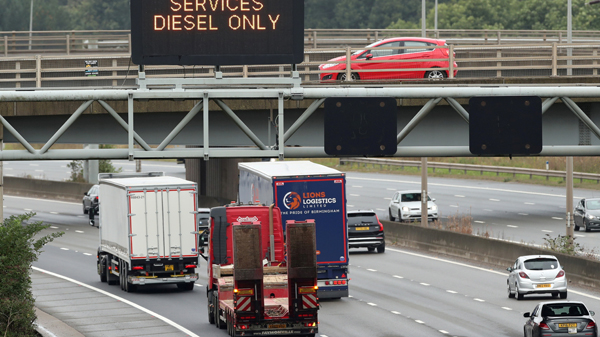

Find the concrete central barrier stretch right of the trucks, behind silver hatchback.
[{"left": 381, "top": 220, "right": 600, "bottom": 288}]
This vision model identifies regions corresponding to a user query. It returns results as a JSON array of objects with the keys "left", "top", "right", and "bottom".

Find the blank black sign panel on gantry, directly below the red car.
[{"left": 324, "top": 97, "right": 398, "bottom": 156}]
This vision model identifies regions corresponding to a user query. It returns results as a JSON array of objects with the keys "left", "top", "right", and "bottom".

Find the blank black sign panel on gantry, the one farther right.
[{"left": 469, "top": 96, "right": 542, "bottom": 155}]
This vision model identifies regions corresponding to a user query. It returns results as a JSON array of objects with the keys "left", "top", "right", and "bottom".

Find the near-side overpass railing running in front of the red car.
[{"left": 0, "top": 41, "right": 600, "bottom": 88}]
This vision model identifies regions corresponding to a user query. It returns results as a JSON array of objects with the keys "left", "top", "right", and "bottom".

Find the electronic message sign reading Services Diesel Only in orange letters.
[{"left": 131, "top": 0, "right": 304, "bottom": 65}]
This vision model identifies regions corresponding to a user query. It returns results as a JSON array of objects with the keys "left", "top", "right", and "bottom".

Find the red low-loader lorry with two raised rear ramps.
[{"left": 206, "top": 204, "right": 319, "bottom": 336}]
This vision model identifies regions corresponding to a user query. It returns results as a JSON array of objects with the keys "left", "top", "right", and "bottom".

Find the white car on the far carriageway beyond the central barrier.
[{"left": 388, "top": 190, "right": 438, "bottom": 221}]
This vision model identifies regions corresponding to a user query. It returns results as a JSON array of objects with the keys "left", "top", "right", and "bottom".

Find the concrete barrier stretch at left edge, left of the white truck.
[{"left": 4, "top": 177, "right": 93, "bottom": 202}]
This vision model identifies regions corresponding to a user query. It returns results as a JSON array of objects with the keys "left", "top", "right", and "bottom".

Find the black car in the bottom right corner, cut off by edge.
[{"left": 523, "top": 301, "right": 598, "bottom": 337}]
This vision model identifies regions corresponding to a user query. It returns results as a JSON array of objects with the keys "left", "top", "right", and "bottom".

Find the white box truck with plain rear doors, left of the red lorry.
[{"left": 97, "top": 172, "right": 199, "bottom": 292}]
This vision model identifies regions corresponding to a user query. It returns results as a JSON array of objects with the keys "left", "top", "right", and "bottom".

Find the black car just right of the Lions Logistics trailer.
[{"left": 347, "top": 210, "right": 385, "bottom": 253}]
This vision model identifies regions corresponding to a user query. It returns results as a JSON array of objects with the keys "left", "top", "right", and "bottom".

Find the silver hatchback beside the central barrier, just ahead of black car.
[{"left": 506, "top": 255, "right": 567, "bottom": 300}]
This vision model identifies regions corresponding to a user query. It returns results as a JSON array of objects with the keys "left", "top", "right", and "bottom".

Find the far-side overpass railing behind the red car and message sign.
[{"left": 0, "top": 29, "right": 600, "bottom": 57}]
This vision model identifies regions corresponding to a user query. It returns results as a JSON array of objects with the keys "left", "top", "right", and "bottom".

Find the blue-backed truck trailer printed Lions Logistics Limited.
[{"left": 238, "top": 161, "right": 349, "bottom": 298}]
